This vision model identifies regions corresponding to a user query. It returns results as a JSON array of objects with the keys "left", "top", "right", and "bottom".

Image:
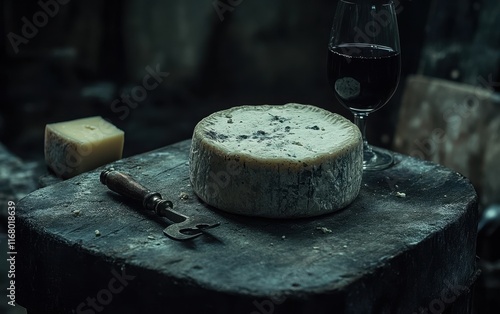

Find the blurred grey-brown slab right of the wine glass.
[{"left": 394, "top": 76, "right": 500, "bottom": 207}]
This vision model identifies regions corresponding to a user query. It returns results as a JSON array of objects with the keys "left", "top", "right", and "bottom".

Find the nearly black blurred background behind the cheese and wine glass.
[{"left": 0, "top": 0, "right": 430, "bottom": 159}]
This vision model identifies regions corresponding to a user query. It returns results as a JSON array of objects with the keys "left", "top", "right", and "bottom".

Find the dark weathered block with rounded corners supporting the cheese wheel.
[{"left": 16, "top": 141, "right": 478, "bottom": 313}]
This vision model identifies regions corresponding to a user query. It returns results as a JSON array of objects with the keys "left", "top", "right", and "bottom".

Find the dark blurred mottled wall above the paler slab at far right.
[{"left": 418, "top": 0, "right": 500, "bottom": 88}]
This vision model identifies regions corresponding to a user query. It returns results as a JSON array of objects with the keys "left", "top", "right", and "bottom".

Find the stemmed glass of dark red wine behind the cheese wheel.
[{"left": 328, "top": 0, "right": 401, "bottom": 170}]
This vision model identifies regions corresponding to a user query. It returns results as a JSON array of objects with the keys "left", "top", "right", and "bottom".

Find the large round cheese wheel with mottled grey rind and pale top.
[{"left": 190, "top": 104, "right": 363, "bottom": 218}]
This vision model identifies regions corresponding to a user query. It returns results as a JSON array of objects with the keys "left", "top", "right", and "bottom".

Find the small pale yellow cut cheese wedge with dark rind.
[{"left": 45, "top": 116, "right": 124, "bottom": 179}]
